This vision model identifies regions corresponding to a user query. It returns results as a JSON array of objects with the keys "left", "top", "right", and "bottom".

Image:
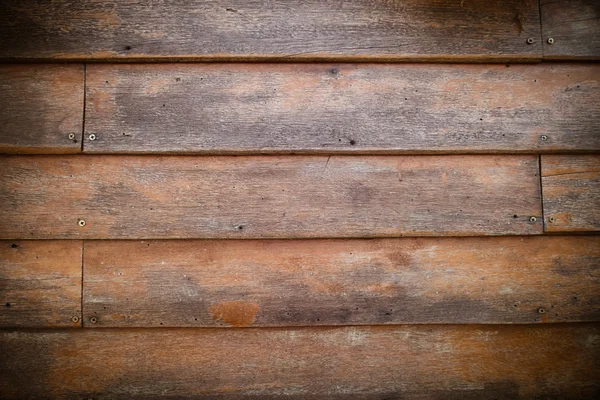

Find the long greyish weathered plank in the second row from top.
[{"left": 84, "top": 64, "right": 600, "bottom": 154}]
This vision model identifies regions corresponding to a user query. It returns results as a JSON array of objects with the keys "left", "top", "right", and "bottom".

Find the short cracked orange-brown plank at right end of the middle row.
[{"left": 541, "top": 155, "right": 600, "bottom": 232}]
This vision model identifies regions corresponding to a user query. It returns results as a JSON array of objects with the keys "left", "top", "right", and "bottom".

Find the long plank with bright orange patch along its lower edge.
[{"left": 83, "top": 236, "right": 600, "bottom": 327}]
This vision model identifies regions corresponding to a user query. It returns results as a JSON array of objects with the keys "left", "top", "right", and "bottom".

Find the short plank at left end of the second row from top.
[{"left": 0, "top": 65, "right": 84, "bottom": 154}]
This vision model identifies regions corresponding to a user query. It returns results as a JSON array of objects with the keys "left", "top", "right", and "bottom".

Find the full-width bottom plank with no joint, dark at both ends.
[{"left": 0, "top": 323, "right": 600, "bottom": 399}]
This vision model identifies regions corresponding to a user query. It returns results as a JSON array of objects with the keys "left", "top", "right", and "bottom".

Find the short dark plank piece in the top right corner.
[{"left": 540, "top": 0, "right": 600, "bottom": 60}]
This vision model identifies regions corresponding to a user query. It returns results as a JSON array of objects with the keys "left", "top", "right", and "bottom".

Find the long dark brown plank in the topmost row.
[{"left": 0, "top": 0, "right": 542, "bottom": 61}]
